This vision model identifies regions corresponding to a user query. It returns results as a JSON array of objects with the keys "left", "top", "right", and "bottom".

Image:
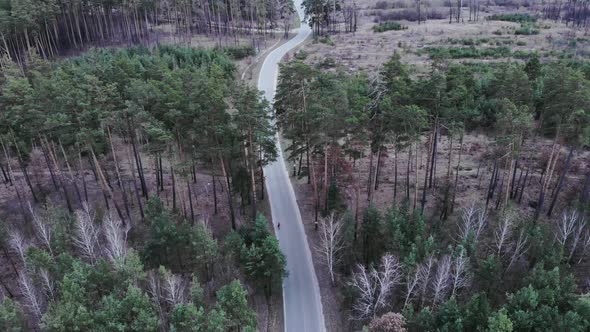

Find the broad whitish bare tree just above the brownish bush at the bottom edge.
[{"left": 349, "top": 255, "right": 401, "bottom": 320}]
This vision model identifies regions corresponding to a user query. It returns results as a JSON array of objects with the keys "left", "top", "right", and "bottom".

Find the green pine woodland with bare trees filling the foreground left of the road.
[{"left": 0, "top": 46, "right": 285, "bottom": 331}]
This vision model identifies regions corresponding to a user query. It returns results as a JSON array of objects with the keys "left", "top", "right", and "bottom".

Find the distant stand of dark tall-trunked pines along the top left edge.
[{"left": 0, "top": 0, "right": 294, "bottom": 63}]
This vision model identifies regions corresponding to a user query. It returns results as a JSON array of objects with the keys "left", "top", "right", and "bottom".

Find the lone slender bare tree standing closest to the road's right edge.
[{"left": 317, "top": 213, "right": 344, "bottom": 285}]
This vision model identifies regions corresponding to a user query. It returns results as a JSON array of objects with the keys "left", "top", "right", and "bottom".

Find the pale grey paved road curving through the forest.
[{"left": 258, "top": 0, "right": 326, "bottom": 332}]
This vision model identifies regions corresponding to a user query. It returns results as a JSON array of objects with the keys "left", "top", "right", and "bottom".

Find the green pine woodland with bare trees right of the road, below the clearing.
[{"left": 274, "top": 54, "right": 590, "bottom": 331}]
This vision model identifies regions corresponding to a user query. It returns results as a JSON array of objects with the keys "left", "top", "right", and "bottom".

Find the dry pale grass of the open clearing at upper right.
[{"left": 304, "top": 0, "right": 590, "bottom": 73}]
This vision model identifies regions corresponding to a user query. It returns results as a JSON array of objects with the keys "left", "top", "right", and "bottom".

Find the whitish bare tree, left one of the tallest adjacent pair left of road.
[{"left": 73, "top": 203, "right": 98, "bottom": 263}]
